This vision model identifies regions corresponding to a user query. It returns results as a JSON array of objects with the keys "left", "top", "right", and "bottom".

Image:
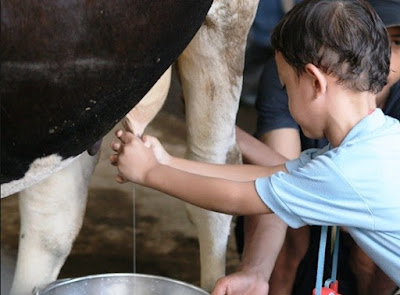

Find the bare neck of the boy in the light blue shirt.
[{"left": 324, "top": 89, "right": 376, "bottom": 147}]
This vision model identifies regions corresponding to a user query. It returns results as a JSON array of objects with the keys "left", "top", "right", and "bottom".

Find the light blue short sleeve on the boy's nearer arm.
[{"left": 255, "top": 149, "right": 374, "bottom": 229}]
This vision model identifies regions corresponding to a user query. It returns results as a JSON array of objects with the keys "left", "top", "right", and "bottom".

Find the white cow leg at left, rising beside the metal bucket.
[{"left": 11, "top": 152, "right": 98, "bottom": 295}]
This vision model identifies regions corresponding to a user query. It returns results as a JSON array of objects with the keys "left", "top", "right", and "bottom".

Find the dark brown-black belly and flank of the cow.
[{"left": 0, "top": 0, "right": 212, "bottom": 184}]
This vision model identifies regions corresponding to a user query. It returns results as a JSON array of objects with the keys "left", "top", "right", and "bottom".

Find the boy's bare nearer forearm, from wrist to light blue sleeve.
[{"left": 143, "top": 164, "right": 271, "bottom": 215}]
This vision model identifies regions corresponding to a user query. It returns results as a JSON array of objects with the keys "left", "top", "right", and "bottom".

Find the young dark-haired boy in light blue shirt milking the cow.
[{"left": 111, "top": 0, "right": 400, "bottom": 294}]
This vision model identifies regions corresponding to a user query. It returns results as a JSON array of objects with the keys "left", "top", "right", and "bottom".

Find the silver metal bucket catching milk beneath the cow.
[{"left": 33, "top": 273, "right": 209, "bottom": 295}]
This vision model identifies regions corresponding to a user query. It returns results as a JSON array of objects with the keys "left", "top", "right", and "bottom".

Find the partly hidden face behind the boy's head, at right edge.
[{"left": 377, "top": 27, "right": 400, "bottom": 106}]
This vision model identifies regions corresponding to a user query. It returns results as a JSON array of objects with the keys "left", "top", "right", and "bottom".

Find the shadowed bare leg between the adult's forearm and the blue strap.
[{"left": 269, "top": 226, "right": 310, "bottom": 295}]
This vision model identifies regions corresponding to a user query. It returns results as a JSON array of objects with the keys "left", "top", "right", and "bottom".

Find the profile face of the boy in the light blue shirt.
[{"left": 275, "top": 52, "right": 324, "bottom": 139}]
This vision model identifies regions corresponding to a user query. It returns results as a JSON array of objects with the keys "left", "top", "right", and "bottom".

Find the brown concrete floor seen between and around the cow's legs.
[{"left": 1, "top": 71, "right": 255, "bottom": 294}]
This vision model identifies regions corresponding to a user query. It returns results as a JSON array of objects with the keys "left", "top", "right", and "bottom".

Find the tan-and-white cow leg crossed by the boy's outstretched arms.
[{"left": 178, "top": 0, "right": 258, "bottom": 290}]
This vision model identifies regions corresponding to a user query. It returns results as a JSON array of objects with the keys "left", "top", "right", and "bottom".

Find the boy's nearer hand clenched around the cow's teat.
[{"left": 110, "top": 130, "right": 161, "bottom": 184}]
